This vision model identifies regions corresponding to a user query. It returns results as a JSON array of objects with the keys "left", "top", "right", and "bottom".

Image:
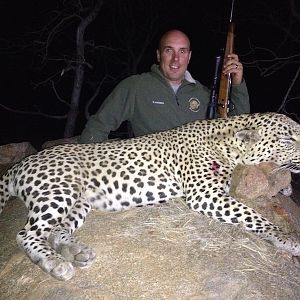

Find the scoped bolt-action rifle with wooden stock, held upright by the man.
[{"left": 207, "top": 0, "right": 235, "bottom": 119}]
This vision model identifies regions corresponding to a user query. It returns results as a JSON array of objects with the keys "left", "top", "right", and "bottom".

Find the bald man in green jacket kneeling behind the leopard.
[{"left": 79, "top": 30, "right": 250, "bottom": 143}]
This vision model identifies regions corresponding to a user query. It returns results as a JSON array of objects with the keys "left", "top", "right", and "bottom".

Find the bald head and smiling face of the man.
[{"left": 156, "top": 31, "right": 191, "bottom": 84}]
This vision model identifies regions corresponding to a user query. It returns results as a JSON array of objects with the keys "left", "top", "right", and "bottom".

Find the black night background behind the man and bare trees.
[{"left": 0, "top": 0, "right": 300, "bottom": 147}]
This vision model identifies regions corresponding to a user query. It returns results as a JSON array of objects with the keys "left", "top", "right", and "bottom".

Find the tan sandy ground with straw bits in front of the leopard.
[{"left": 0, "top": 199, "right": 300, "bottom": 300}]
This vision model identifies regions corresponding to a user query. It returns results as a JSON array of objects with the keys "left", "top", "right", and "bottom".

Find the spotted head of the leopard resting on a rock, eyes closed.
[{"left": 236, "top": 113, "right": 300, "bottom": 173}]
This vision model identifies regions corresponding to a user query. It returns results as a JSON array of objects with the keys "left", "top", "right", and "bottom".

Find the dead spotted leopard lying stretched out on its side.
[{"left": 0, "top": 112, "right": 300, "bottom": 280}]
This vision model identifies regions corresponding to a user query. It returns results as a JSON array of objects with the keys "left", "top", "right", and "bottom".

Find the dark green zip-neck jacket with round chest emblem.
[{"left": 79, "top": 65, "right": 250, "bottom": 143}]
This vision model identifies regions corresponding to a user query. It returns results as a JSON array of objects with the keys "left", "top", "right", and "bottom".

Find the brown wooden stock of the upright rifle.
[{"left": 217, "top": 22, "right": 235, "bottom": 118}]
